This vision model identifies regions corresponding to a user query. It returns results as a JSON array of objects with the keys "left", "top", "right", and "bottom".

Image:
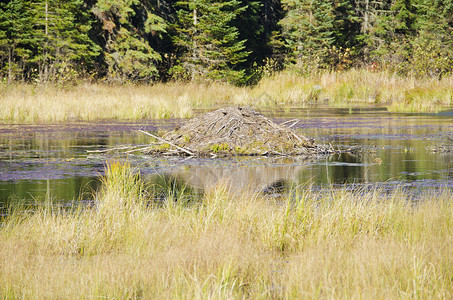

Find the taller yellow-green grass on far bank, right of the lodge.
[{"left": 253, "top": 69, "right": 453, "bottom": 112}]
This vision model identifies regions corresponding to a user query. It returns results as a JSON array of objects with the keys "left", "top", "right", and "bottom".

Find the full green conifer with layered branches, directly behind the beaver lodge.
[{"left": 172, "top": 0, "right": 249, "bottom": 83}]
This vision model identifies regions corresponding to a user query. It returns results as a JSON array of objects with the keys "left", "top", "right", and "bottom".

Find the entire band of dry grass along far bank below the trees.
[{"left": 0, "top": 70, "right": 453, "bottom": 123}]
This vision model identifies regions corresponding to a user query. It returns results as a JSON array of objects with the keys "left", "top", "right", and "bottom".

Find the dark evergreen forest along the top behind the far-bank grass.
[{"left": 0, "top": 0, "right": 453, "bottom": 85}]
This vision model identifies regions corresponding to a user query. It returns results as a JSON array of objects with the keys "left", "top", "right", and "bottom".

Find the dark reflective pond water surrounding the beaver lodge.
[{"left": 0, "top": 107, "right": 453, "bottom": 209}]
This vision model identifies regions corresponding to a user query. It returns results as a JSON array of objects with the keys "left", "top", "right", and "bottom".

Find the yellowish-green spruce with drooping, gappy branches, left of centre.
[{"left": 93, "top": 0, "right": 167, "bottom": 81}]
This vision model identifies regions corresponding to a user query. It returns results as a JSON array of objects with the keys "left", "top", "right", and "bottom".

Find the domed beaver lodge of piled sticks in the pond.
[{"left": 141, "top": 107, "right": 336, "bottom": 157}]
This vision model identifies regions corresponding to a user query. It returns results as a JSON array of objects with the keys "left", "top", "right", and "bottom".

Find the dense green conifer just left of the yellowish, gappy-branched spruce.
[{"left": 30, "top": 0, "right": 100, "bottom": 82}]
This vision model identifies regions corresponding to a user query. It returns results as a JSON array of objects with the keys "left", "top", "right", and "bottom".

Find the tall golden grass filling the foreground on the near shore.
[{"left": 0, "top": 164, "right": 453, "bottom": 299}]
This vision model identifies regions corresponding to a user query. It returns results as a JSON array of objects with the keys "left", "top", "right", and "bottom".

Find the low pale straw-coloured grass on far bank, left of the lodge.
[{"left": 0, "top": 83, "right": 240, "bottom": 123}]
